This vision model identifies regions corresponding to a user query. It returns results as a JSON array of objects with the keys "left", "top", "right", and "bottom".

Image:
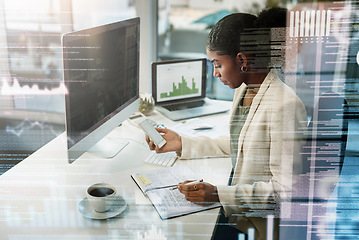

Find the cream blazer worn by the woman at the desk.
[{"left": 181, "top": 70, "right": 307, "bottom": 239}]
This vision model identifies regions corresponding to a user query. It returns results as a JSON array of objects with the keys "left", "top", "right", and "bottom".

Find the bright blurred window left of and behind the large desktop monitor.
[{"left": 0, "top": 0, "right": 136, "bottom": 175}]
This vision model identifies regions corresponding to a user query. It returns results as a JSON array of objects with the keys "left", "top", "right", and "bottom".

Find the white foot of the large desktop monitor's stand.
[{"left": 87, "top": 137, "right": 129, "bottom": 158}]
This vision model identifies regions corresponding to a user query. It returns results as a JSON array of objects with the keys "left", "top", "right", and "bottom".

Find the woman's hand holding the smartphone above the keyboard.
[{"left": 146, "top": 128, "right": 182, "bottom": 153}]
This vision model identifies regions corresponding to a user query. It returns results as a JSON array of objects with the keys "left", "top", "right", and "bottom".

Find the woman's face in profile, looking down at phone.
[{"left": 207, "top": 49, "right": 245, "bottom": 89}]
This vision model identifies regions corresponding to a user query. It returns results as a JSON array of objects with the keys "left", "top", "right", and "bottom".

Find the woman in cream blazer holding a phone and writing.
[{"left": 146, "top": 10, "right": 307, "bottom": 239}]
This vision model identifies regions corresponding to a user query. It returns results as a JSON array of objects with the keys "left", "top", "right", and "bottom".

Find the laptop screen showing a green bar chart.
[{"left": 152, "top": 58, "right": 207, "bottom": 103}]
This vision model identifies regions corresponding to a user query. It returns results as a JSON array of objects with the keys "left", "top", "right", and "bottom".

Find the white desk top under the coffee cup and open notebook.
[{"left": 0, "top": 103, "right": 231, "bottom": 240}]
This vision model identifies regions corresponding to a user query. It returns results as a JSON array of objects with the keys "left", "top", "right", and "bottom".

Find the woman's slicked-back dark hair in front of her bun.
[{"left": 207, "top": 13, "right": 257, "bottom": 56}]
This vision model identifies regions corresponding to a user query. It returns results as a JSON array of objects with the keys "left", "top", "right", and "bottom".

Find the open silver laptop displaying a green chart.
[{"left": 152, "top": 58, "right": 229, "bottom": 121}]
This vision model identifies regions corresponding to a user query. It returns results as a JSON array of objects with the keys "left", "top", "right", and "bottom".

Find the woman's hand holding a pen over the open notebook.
[{"left": 177, "top": 181, "right": 219, "bottom": 205}]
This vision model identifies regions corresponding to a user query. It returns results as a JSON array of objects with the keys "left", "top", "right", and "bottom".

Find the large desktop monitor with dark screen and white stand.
[{"left": 62, "top": 18, "right": 140, "bottom": 163}]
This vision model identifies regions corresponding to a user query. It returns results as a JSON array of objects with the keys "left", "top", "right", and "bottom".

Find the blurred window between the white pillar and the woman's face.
[{"left": 157, "top": 0, "right": 281, "bottom": 100}]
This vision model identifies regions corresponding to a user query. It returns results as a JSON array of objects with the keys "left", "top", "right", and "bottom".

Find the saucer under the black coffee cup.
[{"left": 78, "top": 195, "right": 127, "bottom": 219}]
